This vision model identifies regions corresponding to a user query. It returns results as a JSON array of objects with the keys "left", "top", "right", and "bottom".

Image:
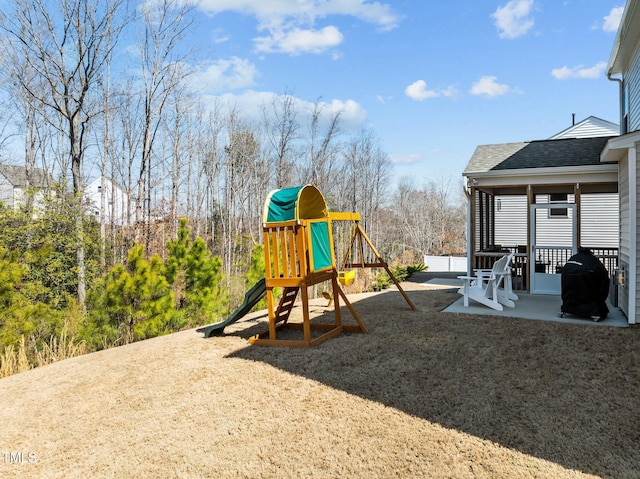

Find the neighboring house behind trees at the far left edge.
[{"left": 0, "top": 165, "right": 53, "bottom": 209}]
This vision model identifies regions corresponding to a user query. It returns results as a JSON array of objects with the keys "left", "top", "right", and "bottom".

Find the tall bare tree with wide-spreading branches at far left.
[{"left": 0, "top": 0, "right": 130, "bottom": 305}]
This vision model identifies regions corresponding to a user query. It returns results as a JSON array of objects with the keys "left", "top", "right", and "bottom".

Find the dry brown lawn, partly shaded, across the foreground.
[{"left": 0, "top": 282, "right": 640, "bottom": 479}]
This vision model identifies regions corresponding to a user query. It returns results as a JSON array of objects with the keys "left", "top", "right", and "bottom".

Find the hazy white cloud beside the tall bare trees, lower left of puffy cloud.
[{"left": 190, "top": 57, "right": 258, "bottom": 93}]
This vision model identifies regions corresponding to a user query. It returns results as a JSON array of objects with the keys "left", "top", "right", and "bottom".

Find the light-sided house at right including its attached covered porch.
[{"left": 463, "top": 0, "right": 640, "bottom": 324}]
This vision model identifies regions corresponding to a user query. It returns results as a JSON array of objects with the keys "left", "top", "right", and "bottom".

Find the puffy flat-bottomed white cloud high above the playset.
[{"left": 254, "top": 26, "right": 343, "bottom": 55}]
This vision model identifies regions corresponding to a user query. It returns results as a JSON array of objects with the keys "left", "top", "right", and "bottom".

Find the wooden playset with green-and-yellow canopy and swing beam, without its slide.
[{"left": 249, "top": 185, "right": 416, "bottom": 347}]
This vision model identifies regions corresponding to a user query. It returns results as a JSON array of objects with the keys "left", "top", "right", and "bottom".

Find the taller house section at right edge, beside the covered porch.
[{"left": 600, "top": 0, "right": 640, "bottom": 324}]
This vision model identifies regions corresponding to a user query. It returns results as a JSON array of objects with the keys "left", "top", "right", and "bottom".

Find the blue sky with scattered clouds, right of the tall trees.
[{"left": 187, "top": 0, "right": 624, "bottom": 183}]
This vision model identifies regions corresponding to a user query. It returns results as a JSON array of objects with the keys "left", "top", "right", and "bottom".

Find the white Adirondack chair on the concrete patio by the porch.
[{"left": 458, "top": 253, "right": 518, "bottom": 311}]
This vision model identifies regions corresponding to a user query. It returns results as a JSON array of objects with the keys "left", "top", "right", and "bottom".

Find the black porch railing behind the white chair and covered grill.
[{"left": 472, "top": 246, "right": 618, "bottom": 291}]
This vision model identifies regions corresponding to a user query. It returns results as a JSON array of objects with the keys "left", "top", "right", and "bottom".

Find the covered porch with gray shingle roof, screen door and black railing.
[{"left": 463, "top": 137, "right": 619, "bottom": 294}]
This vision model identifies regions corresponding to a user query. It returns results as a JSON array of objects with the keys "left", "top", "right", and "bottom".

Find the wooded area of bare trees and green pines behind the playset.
[{"left": 0, "top": 0, "right": 466, "bottom": 376}]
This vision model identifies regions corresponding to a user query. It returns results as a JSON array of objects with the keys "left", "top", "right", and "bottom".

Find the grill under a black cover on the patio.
[{"left": 560, "top": 248, "right": 609, "bottom": 319}]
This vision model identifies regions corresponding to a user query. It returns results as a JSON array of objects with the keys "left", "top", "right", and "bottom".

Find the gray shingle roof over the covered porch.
[{"left": 463, "top": 136, "right": 612, "bottom": 174}]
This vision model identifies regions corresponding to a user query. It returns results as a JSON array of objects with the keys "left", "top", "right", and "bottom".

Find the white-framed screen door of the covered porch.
[{"left": 529, "top": 203, "right": 578, "bottom": 295}]
